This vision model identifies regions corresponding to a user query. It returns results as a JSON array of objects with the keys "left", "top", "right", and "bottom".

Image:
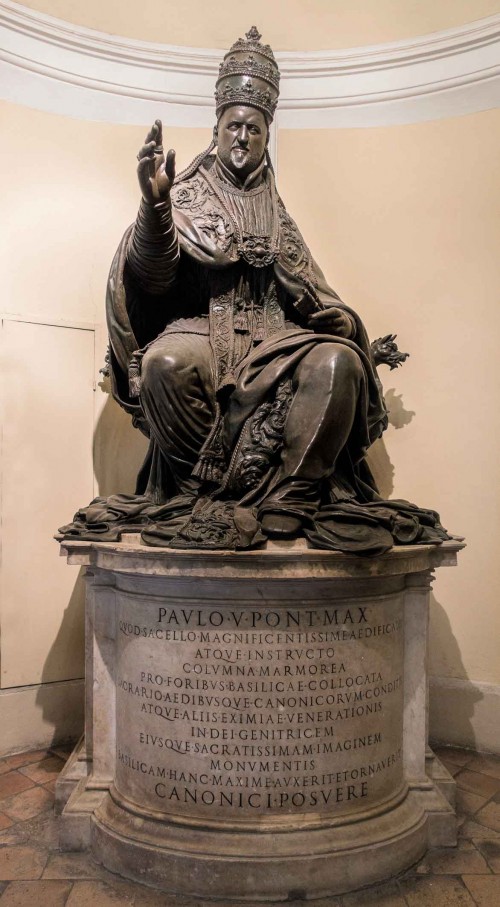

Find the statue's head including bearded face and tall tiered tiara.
[{"left": 215, "top": 26, "right": 280, "bottom": 178}]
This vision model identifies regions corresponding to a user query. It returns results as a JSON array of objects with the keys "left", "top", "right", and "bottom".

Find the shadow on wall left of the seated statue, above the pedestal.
[{"left": 93, "top": 378, "right": 148, "bottom": 497}]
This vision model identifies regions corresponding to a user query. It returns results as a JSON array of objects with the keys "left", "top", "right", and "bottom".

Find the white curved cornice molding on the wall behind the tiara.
[{"left": 0, "top": 0, "right": 500, "bottom": 129}]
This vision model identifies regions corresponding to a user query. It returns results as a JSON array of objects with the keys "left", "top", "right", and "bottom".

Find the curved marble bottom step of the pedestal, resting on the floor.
[{"left": 56, "top": 779, "right": 457, "bottom": 903}]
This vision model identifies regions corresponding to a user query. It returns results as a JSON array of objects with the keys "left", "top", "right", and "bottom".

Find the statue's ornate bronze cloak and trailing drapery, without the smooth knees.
[{"left": 60, "top": 158, "right": 449, "bottom": 555}]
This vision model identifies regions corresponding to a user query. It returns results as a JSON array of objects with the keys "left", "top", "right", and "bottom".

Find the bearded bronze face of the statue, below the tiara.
[{"left": 217, "top": 105, "right": 268, "bottom": 182}]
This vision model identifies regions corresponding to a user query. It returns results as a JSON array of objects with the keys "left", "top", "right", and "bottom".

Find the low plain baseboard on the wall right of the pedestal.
[{"left": 429, "top": 677, "right": 500, "bottom": 755}]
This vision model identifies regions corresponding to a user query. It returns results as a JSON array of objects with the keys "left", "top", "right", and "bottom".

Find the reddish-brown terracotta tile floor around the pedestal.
[{"left": 0, "top": 748, "right": 500, "bottom": 907}]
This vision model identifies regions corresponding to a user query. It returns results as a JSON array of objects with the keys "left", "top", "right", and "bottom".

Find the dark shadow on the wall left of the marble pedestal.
[{"left": 36, "top": 569, "right": 85, "bottom": 743}]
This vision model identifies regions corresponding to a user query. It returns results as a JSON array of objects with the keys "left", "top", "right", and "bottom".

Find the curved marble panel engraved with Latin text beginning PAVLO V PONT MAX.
[{"left": 117, "top": 597, "right": 403, "bottom": 816}]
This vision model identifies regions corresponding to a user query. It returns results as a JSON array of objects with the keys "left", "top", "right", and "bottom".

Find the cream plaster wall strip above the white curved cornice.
[{"left": 20, "top": 0, "right": 498, "bottom": 50}]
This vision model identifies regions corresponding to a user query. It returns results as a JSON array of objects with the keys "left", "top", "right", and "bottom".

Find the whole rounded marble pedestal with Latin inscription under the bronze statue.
[{"left": 57, "top": 537, "right": 462, "bottom": 902}]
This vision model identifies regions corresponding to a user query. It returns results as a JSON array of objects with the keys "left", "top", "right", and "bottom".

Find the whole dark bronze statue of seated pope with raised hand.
[{"left": 63, "top": 27, "right": 448, "bottom": 554}]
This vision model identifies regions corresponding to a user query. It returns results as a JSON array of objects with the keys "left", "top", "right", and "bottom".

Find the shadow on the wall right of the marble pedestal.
[{"left": 429, "top": 593, "right": 484, "bottom": 749}]
